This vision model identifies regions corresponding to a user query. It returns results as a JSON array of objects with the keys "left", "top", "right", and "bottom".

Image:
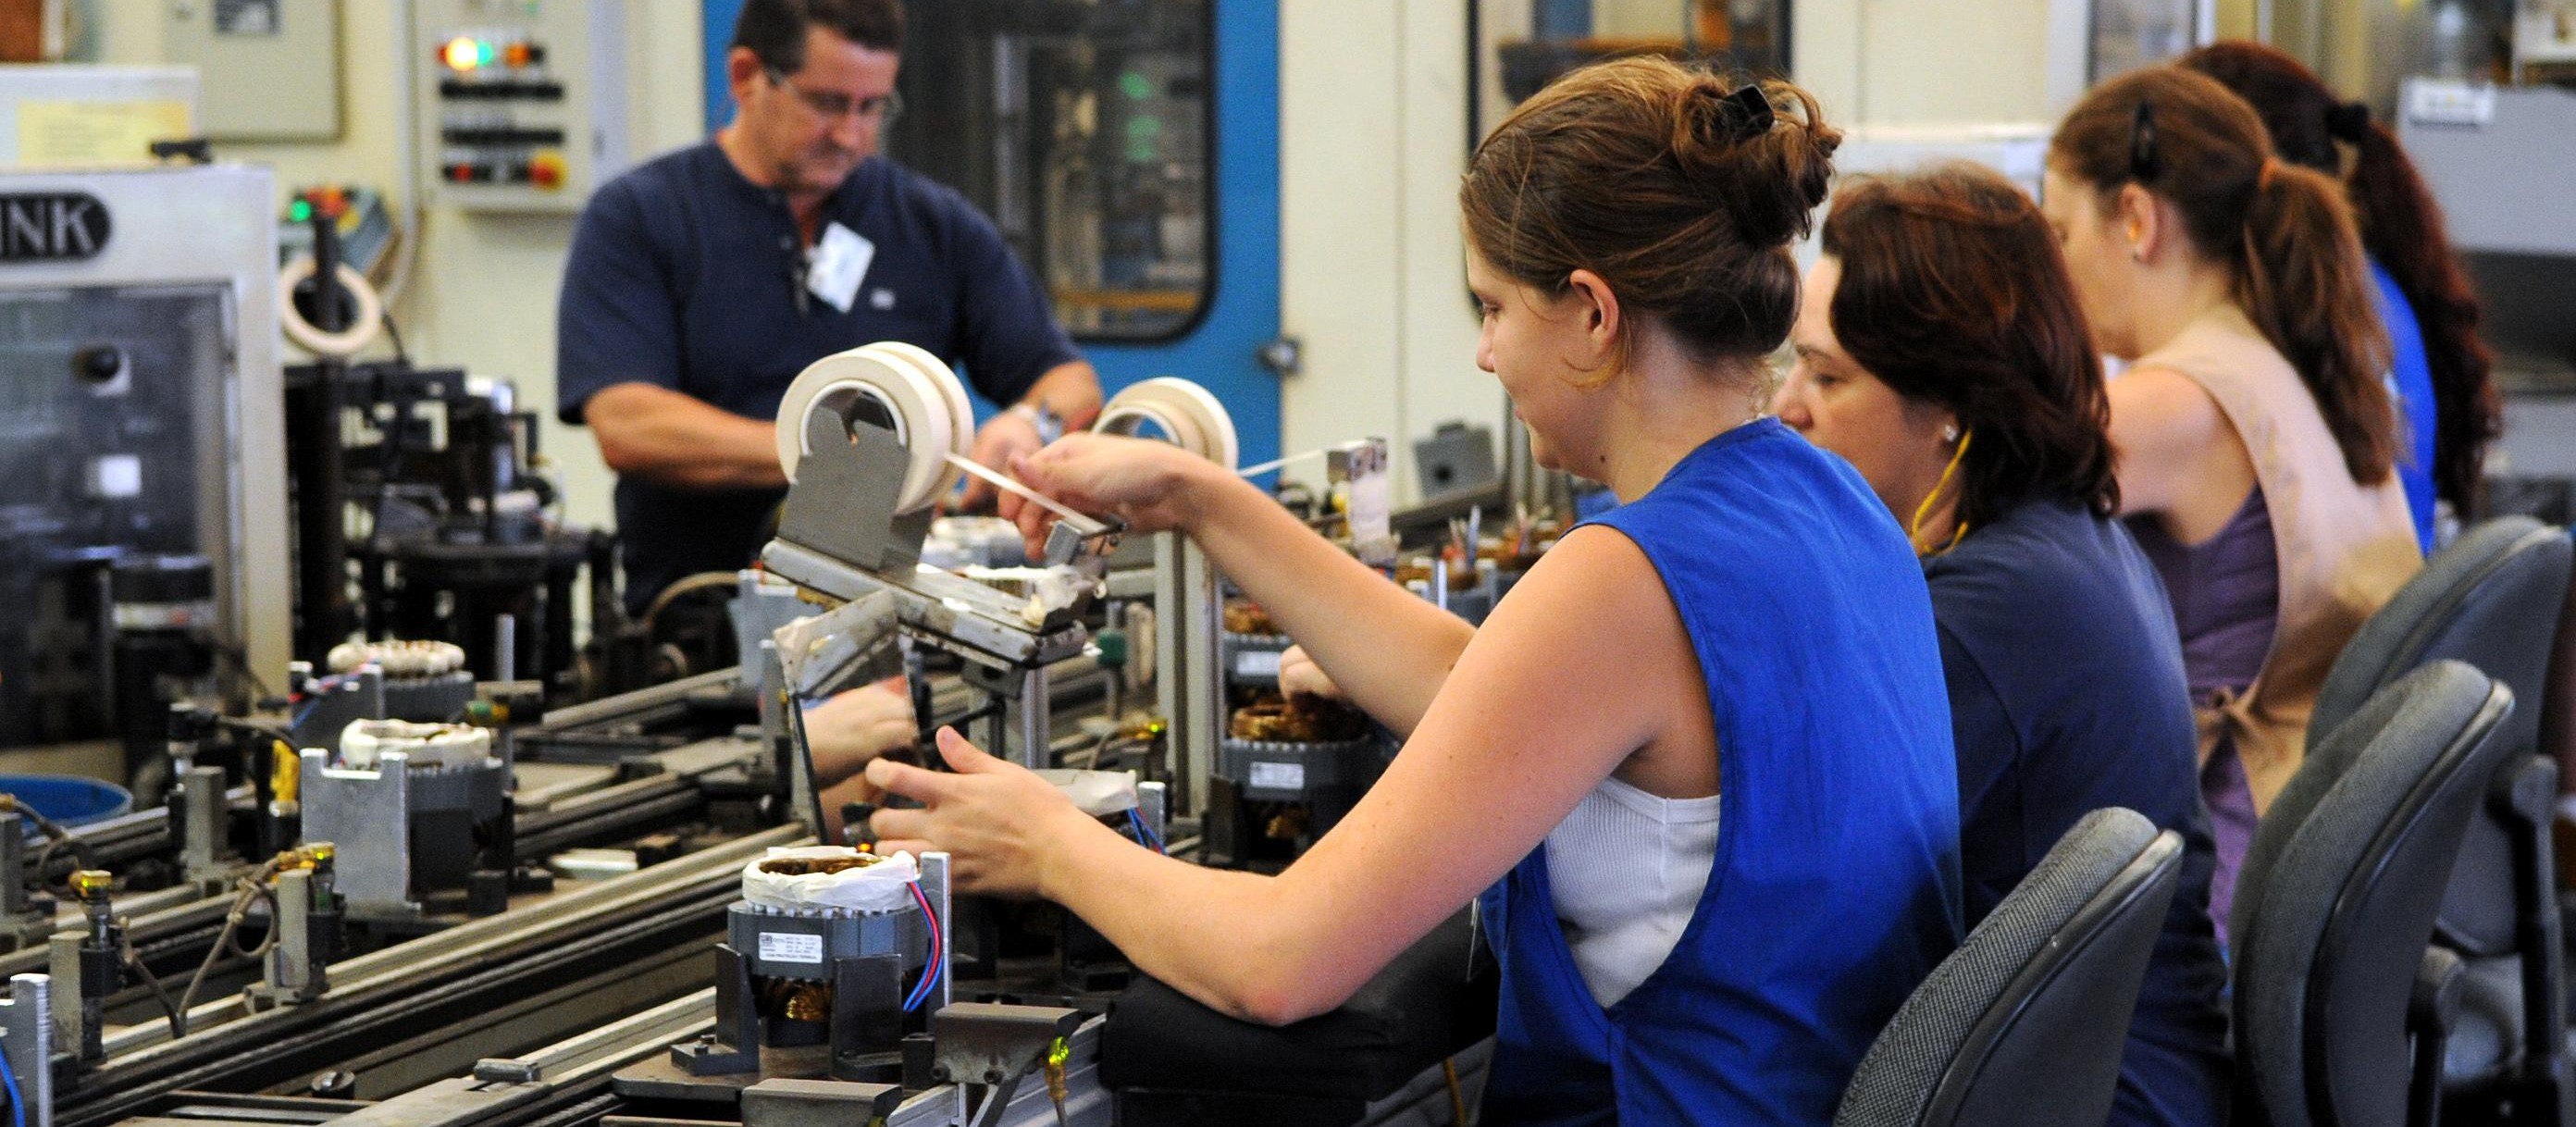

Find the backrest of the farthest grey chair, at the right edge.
[{"left": 2308, "top": 517, "right": 2576, "bottom": 957}]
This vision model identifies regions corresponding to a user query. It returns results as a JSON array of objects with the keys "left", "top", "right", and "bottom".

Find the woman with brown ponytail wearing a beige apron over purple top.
[{"left": 2043, "top": 67, "right": 2424, "bottom": 926}]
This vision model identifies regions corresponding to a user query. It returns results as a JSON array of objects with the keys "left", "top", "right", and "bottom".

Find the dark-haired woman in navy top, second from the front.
[{"left": 1775, "top": 165, "right": 2231, "bottom": 1127}]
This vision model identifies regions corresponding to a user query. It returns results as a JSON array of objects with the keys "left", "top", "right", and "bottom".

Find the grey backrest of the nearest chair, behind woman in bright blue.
[{"left": 1834, "top": 808, "right": 2182, "bottom": 1127}]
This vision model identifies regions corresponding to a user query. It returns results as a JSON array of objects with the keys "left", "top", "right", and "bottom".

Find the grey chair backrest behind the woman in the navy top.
[{"left": 2228, "top": 662, "right": 2514, "bottom": 1127}]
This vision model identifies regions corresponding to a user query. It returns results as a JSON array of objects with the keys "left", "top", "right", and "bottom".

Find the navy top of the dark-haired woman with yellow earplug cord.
[{"left": 1925, "top": 499, "right": 2234, "bottom": 1127}]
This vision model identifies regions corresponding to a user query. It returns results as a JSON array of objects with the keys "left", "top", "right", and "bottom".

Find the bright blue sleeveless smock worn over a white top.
[{"left": 1481, "top": 419, "right": 1958, "bottom": 1124}]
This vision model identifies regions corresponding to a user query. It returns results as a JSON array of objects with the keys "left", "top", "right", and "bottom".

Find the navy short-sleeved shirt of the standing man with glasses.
[{"left": 554, "top": 142, "right": 1077, "bottom": 610}]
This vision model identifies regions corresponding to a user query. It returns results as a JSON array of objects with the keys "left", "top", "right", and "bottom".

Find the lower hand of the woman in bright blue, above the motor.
[{"left": 868, "top": 728, "right": 1108, "bottom": 896}]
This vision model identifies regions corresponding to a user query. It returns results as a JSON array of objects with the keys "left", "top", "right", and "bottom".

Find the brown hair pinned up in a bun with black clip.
[{"left": 1458, "top": 56, "right": 1842, "bottom": 373}]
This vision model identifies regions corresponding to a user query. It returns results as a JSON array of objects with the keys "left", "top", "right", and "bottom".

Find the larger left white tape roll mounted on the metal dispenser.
[{"left": 778, "top": 340, "right": 973, "bottom": 512}]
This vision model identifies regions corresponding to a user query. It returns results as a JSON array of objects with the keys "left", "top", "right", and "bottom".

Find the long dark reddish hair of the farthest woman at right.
[{"left": 2179, "top": 41, "right": 2504, "bottom": 520}]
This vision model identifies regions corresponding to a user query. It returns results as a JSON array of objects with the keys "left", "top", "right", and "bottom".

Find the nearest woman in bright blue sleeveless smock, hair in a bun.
[{"left": 868, "top": 59, "right": 1958, "bottom": 1124}]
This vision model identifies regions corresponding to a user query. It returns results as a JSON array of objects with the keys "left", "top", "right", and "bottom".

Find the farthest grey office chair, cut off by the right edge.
[{"left": 2308, "top": 517, "right": 2576, "bottom": 1124}]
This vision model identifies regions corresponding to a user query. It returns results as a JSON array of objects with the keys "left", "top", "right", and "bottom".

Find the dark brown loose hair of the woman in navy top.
[{"left": 1824, "top": 165, "right": 2120, "bottom": 525}]
